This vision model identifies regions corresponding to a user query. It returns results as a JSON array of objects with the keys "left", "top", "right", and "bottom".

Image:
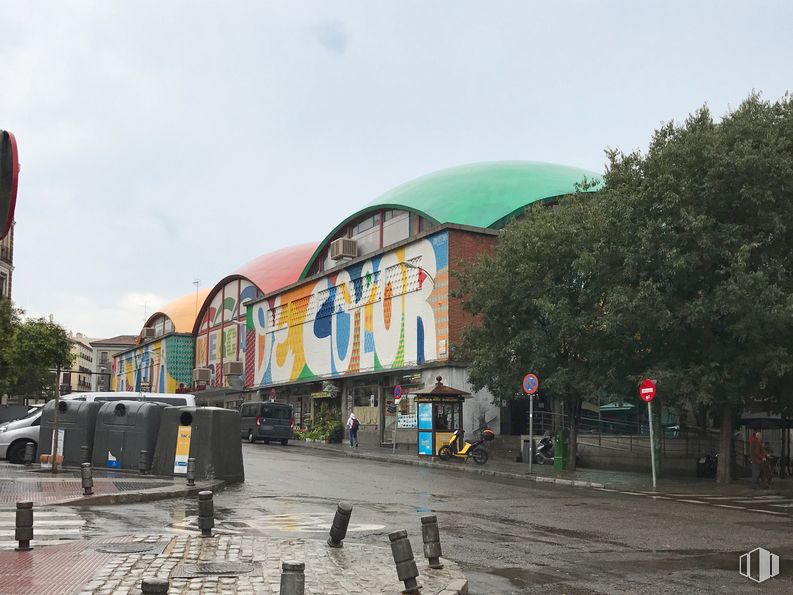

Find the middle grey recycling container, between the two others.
[{"left": 91, "top": 401, "right": 164, "bottom": 470}]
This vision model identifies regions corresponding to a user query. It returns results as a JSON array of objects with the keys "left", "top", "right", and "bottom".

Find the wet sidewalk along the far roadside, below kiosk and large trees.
[{"left": 290, "top": 441, "right": 793, "bottom": 495}]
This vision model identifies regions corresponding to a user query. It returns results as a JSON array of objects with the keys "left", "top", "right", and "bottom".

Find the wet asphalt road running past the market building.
[{"left": 41, "top": 444, "right": 793, "bottom": 593}]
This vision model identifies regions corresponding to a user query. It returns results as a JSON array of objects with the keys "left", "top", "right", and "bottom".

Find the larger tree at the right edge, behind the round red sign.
[{"left": 600, "top": 95, "right": 793, "bottom": 482}]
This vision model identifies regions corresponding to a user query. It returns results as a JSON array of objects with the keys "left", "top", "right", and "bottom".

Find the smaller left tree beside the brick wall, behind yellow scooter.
[{"left": 460, "top": 181, "right": 606, "bottom": 469}]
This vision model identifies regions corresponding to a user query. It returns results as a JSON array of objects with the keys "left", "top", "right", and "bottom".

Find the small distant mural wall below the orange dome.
[{"left": 112, "top": 335, "right": 194, "bottom": 393}]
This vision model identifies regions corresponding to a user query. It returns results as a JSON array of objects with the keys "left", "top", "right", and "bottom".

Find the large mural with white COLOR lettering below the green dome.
[{"left": 254, "top": 232, "right": 449, "bottom": 386}]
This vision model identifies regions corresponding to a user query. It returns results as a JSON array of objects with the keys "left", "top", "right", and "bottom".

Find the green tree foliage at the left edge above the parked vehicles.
[{"left": 0, "top": 300, "right": 73, "bottom": 397}]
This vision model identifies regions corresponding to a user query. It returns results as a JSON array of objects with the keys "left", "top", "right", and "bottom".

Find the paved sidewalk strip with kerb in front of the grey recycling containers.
[{"left": 0, "top": 463, "right": 224, "bottom": 508}]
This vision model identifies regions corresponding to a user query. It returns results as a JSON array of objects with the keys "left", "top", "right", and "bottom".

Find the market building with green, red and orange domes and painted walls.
[{"left": 114, "top": 161, "right": 597, "bottom": 444}]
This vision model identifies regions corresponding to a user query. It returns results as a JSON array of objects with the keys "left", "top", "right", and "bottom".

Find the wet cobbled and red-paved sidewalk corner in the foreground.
[{"left": 0, "top": 535, "right": 468, "bottom": 595}]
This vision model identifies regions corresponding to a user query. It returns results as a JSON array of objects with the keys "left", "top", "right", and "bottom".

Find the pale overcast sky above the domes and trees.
[{"left": 0, "top": 0, "right": 793, "bottom": 338}]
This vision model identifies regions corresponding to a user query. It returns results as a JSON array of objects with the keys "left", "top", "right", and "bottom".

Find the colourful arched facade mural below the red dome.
[{"left": 195, "top": 279, "right": 262, "bottom": 388}]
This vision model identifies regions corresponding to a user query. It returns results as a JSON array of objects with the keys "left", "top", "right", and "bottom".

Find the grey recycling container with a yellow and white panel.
[{"left": 152, "top": 407, "right": 245, "bottom": 483}]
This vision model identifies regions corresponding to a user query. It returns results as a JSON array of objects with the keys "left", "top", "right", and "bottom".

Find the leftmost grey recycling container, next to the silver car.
[{"left": 38, "top": 399, "right": 102, "bottom": 467}]
